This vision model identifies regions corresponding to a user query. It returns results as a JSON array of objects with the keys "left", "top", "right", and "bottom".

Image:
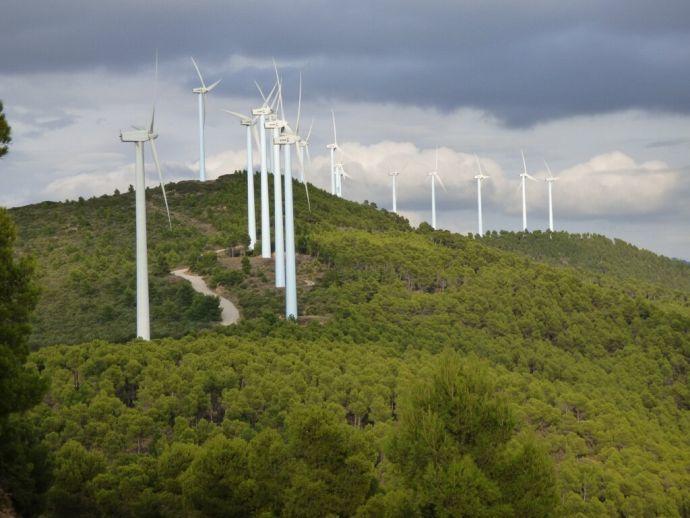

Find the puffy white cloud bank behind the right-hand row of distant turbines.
[{"left": 304, "top": 141, "right": 690, "bottom": 220}]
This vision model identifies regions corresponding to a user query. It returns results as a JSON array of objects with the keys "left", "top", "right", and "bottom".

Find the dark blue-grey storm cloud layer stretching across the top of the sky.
[{"left": 0, "top": 0, "right": 690, "bottom": 125}]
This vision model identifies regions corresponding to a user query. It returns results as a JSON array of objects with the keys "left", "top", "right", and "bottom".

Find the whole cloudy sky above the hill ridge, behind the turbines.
[{"left": 0, "top": 0, "right": 690, "bottom": 259}]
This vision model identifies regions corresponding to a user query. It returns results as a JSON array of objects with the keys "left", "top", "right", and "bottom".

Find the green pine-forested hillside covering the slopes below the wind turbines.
[{"left": 2, "top": 174, "right": 690, "bottom": 517}]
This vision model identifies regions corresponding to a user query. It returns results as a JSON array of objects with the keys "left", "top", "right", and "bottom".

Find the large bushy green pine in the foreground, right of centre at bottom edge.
[{"left": 389, "top": 352, "right": 556, "bottom": 516}]
